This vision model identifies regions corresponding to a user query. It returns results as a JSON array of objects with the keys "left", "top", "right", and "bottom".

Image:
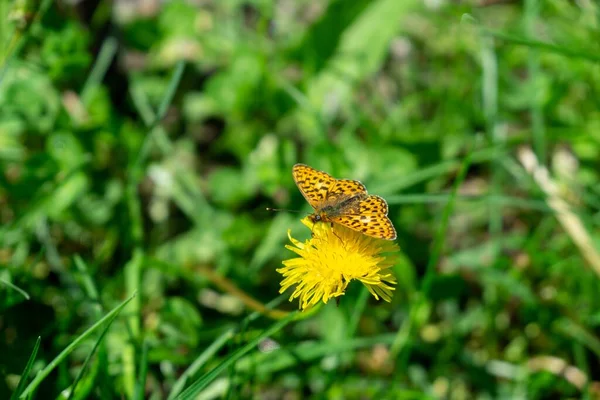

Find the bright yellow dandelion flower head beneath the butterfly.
[{"left": 277, "top": 217, "right": 399, "bottom": 310}]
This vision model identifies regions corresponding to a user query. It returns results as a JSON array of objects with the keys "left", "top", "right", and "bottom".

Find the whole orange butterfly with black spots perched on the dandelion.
[{"left": 292, "top": 164, "right": 396, "bottom": 240}]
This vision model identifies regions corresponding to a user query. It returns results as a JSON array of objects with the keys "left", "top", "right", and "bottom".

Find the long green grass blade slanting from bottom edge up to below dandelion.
[{"left": 176, "top": 312, "right": 298, "bottom": 400}]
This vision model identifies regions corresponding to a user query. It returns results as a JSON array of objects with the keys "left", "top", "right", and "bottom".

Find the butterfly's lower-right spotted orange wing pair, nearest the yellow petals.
[{"left": 331, "top": 196, "right": 396, "bottom": 240}]
